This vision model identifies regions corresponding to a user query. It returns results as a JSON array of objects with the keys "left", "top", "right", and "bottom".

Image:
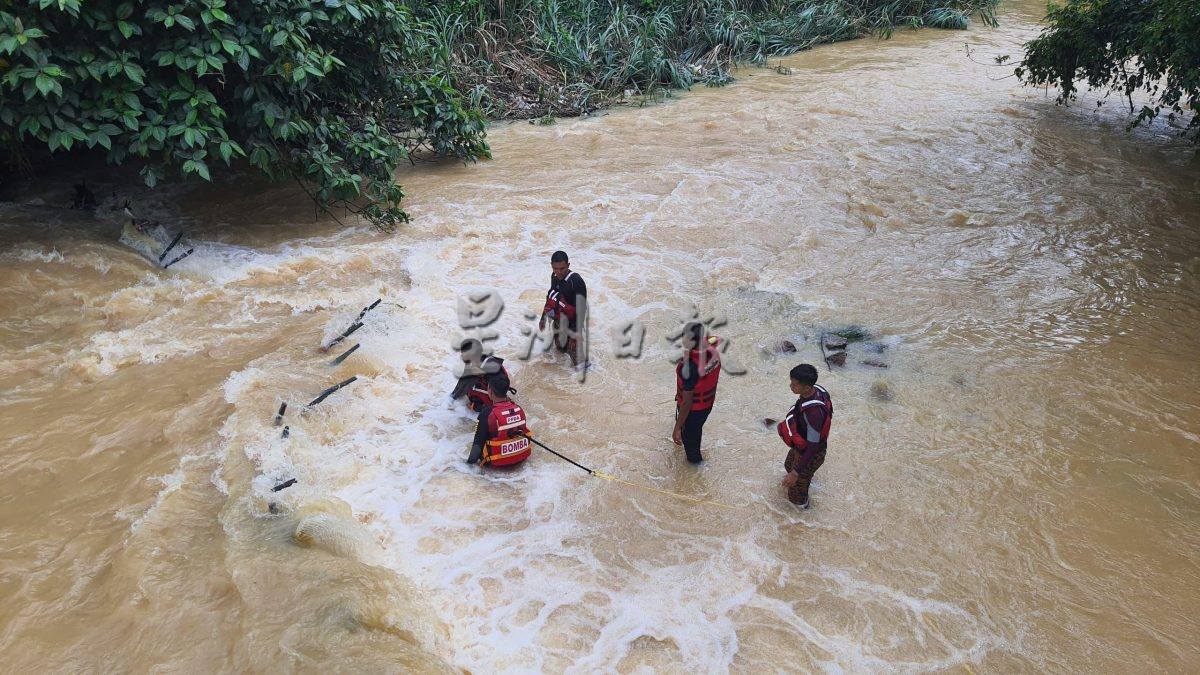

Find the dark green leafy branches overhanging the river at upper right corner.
[{"left": 1016, "top": 0, "right": 1200, "bottom": 143}]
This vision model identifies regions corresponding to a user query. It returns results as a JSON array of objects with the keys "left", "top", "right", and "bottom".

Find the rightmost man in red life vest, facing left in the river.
[{"left": 775, "top": 363, "right": 833, "bottom": 508}]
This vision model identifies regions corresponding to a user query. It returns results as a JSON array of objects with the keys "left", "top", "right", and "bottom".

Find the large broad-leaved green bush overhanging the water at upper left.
[{"left": 0, "top": 0, "right": 487, "bottom": 228}]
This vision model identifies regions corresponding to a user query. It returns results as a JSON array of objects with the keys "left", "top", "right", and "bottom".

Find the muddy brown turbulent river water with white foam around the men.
[{"left": 0, "top": 2, "right": 1200, "bottom": 673}]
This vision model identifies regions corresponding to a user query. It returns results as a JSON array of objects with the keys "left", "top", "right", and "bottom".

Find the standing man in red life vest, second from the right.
[{"left": 671, "top": 322, "right": 722, "bottom": 464}]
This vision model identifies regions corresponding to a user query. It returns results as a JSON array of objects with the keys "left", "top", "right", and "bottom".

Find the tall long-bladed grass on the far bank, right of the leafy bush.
[{"left": 415, "top": 0, "right": 998, "bottom": 119}]
